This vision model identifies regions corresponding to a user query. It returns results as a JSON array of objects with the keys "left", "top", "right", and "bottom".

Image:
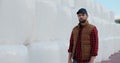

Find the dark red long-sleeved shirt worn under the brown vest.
[{"left": 68, "top": 27, "right": 98, "bottom": 63}]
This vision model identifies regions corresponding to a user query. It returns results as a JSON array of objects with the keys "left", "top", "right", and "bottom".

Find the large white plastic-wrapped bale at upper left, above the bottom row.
[{"left": 0, "top": 0, "right": 34, "bottom": 44}]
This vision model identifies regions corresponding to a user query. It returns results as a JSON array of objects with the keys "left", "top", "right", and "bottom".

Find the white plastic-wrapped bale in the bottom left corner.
[{"left": 0, "top": 45, "right": 29, "bottom": 63}]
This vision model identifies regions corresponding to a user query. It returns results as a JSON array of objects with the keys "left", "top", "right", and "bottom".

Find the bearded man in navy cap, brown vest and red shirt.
[{"left": 68, "top": 8, "right": 98, "bottom": 63}]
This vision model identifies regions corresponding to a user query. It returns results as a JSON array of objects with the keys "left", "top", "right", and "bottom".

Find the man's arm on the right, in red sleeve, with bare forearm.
[{"left": 90, "top": 27, "right": 98, "bottom": 63}]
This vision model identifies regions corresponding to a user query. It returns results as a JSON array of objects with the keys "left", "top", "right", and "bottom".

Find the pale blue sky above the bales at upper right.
[{"left": 94, "top": 0, "right": 120, "bottom": 18}]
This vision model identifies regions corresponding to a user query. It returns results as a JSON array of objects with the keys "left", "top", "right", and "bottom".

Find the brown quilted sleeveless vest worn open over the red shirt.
[{"left": 72, "top": 22, "right": 95, "bottom": 61}]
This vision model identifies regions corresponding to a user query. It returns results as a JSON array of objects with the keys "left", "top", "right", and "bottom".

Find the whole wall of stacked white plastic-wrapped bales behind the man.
[{"left": 0, "top": 0, "right": 120, "bottom": 63}]
